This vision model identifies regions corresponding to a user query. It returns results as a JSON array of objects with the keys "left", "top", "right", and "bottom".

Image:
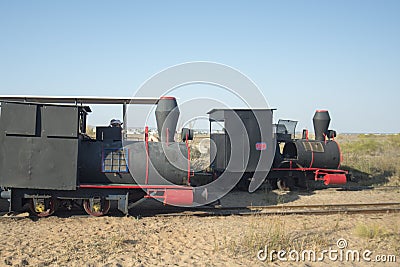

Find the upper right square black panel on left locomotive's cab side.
[{"left": 42, "top": 105, "right": 79, "bottom": 137}]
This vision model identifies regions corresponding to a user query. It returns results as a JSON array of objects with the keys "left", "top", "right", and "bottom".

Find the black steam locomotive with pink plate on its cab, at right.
[{"left": 209, "top": 109, "right": 347, "bottom": 190}]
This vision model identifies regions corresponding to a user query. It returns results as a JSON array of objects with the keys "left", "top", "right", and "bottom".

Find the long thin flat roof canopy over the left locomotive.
[{"left": 0, "top": 95, "right": 159, "bottom": 105}]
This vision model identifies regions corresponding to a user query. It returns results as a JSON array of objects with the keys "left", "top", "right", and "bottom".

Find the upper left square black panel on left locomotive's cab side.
[{"left": 0, "top": 102, "right": 37, "bottom": 136}]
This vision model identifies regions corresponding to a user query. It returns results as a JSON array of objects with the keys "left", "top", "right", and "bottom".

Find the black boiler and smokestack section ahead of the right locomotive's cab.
[{"left": 267, "top": 110, "right": 347, "bottom": 190}]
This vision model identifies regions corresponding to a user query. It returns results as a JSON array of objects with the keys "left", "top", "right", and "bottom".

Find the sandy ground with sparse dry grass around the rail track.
[{"left": 0, "top": 188, "right": 400, "bottom": 266}]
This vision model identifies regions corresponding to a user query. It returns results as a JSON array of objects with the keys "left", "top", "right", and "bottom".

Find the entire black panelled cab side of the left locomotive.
[{"left": 0, "top": 103, "right": 79, "bottom": 190}]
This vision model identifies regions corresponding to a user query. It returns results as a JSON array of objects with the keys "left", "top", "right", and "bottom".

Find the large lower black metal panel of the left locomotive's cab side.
[{"left": 0, "top": 136, "right": 78, "bottom": 190}]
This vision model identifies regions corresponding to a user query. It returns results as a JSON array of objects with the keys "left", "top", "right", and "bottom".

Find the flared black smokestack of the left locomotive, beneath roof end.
[{"left": 156, "top": 96, "right": 179, "bottom": 142}]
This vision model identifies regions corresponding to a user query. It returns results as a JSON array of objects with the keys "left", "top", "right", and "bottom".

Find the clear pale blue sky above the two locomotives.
[{"left": 0, "top": 0, "right": 400, "bottom": 133}]
